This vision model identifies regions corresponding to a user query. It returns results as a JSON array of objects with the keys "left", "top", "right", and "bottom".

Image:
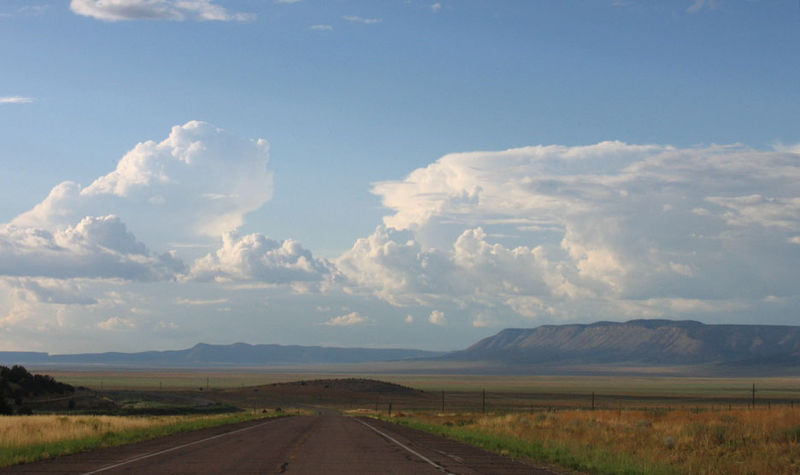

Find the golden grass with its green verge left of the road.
[{"left": 0, "top": 411, "right": 292, "bottom": 467}]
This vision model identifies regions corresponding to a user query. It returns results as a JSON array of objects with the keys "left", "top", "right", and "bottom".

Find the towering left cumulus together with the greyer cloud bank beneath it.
[{"left": 0, "top": 121, "right": 276, "bottom": 303}]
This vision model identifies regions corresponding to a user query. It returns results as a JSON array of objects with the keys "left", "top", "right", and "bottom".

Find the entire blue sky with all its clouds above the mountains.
[{"left": 0, "top": 0, "right": 800, "bottom": 353}]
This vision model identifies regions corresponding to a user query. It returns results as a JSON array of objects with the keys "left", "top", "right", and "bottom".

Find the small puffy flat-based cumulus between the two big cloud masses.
[{"left": 186, "top": 233, "right": 331, "bottom": 284}]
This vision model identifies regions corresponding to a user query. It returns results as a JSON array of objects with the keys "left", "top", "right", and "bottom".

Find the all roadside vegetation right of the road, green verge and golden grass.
[{"left": 378, "top": 408, "right": 800, "bottom": 475}]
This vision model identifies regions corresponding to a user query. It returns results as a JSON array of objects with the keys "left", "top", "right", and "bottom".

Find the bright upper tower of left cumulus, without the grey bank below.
[{"left": 11, "top": 121, "right": 272, "bottom": 243}]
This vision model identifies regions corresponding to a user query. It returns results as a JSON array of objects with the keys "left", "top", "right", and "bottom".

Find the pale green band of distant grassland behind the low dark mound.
[{"left": 40, "top": 365, "right": 800, "bottom": 401}]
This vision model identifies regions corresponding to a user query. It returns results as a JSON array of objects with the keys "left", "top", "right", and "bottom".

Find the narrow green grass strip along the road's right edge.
[{"left": 381, "top": 417, "right": 679, "bottom": 475}]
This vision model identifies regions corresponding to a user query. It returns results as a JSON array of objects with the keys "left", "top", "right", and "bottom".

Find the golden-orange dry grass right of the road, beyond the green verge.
[{"left": 404, "top": 408, "right": 800, "bottom": 475}]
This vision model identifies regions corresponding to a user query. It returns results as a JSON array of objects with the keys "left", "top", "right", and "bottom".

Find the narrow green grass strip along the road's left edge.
[{"left": 0, "top": 412, "right": 279, "bottom": 467}]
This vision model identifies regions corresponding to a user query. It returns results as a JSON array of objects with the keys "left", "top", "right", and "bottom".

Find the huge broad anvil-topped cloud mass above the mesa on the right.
[{"left": 336, "top": 142, "right": 800, "bottom": 324}]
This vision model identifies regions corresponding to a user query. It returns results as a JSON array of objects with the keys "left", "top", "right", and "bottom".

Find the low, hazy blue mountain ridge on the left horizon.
[{"left": 0, "top": 343, "right": 442, "bottom": 367}]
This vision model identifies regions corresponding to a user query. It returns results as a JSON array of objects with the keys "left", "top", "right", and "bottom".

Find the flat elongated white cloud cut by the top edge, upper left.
[{"left": 70, "top": 0, "right": 254, "bottom": 22}]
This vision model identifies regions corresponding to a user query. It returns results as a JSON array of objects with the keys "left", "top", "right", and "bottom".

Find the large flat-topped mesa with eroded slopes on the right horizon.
[{"left": 442, "top": 320, "right": 800, "bottom": 366}]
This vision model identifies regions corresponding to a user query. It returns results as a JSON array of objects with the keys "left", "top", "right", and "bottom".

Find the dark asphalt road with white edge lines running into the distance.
[{"left": 0, "top": 413, "right": 553, "bottom": 475}]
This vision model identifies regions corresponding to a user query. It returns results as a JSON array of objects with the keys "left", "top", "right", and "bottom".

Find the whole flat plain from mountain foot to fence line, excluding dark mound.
[{"left": 40, "top": 368, "right": 800, "bottom": 410}]
